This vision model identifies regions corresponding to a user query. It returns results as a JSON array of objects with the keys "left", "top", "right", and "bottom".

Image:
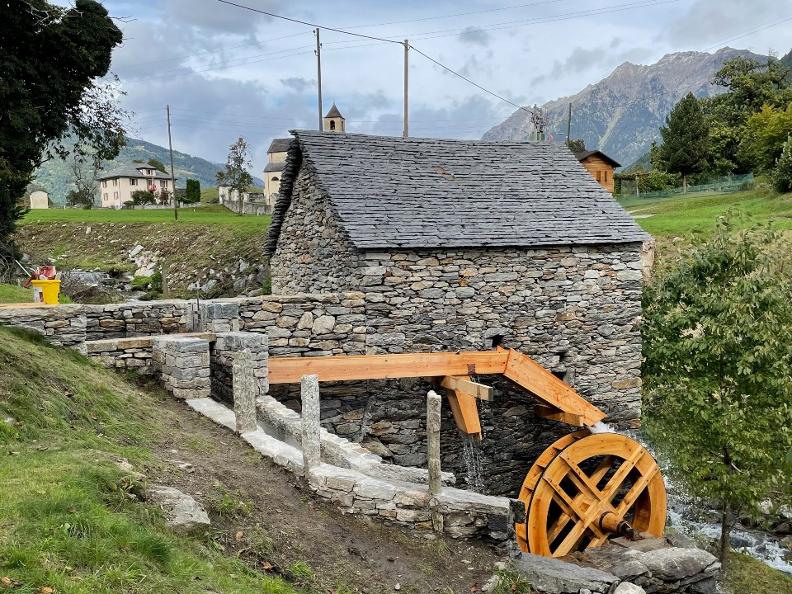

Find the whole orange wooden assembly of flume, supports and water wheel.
[{"left": 268, "top": 348, "right": 666, "bottom": 557}]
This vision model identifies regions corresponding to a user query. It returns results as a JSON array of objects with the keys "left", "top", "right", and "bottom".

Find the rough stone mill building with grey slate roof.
[{"left": 266, "top": 131, "right": 648, "bottom": 494}]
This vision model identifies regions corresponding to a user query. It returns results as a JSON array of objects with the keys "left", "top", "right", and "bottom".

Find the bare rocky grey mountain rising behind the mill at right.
[{"left": 483, "top": 47, "right": 767, "bottom": 165}]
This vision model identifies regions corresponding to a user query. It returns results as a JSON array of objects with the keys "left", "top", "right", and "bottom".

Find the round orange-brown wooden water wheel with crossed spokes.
[{"left": 516, "top": 430, "right": 666, "bottom": 557}]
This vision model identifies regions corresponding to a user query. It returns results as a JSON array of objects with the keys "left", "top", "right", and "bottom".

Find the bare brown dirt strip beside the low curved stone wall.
[{"left": 149, "top": 399, "right": 499, "bottom": 594}]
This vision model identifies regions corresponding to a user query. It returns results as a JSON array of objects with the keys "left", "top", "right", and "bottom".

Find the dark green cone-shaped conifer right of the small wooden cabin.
[{"left": 658, "top": 93, "right": 709, "bottom": 192}]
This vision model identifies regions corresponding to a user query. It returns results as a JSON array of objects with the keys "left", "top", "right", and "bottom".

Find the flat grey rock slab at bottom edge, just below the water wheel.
[{"left": 514, "top": 553, "right": 619, "bottom": 594}]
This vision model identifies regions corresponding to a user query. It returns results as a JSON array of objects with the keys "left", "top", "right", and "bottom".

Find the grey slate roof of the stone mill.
[{"left": 266, "top": 131, "right": 649, "bottom": 255}]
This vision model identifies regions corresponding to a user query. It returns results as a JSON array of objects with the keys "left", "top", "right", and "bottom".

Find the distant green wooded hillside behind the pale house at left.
[{"left": 33, "top": 138, "right": 264, "bottom": 204}]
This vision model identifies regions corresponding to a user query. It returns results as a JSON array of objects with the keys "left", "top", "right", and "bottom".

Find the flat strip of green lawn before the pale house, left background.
[{"left": 22, "top": 204, "right": 270, "bottom": 230}]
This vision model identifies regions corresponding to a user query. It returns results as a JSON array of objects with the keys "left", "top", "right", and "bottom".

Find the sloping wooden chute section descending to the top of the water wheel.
[{"left": 504, "top": 349, "right": 606, "bottom": 425}]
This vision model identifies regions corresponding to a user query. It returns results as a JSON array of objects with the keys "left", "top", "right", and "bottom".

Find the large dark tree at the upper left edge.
[{"left": 0, "top": 0, "right": 124, "bottom": 258}]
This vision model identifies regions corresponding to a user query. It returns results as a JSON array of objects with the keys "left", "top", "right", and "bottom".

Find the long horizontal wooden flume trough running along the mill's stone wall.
[{"left": 268, "top": 351, "right": 509, "bottom": 384}]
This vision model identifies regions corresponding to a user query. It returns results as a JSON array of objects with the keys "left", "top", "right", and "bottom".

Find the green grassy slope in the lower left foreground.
[{"left": 0, "top": 329, "right": 295, "bottom": 594}]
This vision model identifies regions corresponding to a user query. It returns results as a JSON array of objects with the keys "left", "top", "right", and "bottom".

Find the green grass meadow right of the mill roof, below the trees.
[{"left": 619, "top": 190, "right": 792, "bottom": 237}]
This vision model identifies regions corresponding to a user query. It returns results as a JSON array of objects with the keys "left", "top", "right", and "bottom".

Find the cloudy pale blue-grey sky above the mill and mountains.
[{"left": 83, "top": 0, "right": 792, "bottom": 176}]
